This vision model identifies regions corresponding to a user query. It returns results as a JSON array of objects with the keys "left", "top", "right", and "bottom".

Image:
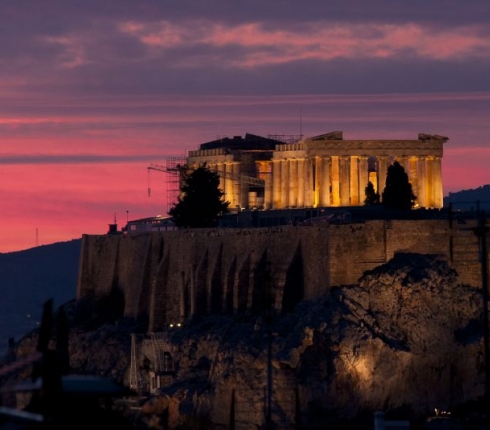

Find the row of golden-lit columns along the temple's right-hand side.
[{"left": 264, "top": 156, "right": 443, "bottom": 209}]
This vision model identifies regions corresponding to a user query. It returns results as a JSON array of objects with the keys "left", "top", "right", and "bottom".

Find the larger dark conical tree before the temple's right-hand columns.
[{"left": 383, "top": 161, "right": 417, "bottom": 210}]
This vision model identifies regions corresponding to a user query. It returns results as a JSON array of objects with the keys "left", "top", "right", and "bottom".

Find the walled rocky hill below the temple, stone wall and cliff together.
[{"left": 72, "top": 213, "right": 490, "bottom": 430}]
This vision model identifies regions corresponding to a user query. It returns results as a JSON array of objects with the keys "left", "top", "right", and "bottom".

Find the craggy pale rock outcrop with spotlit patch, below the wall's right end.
[{"left": 318, "top": 254, "right": 483, "bottom": 422}]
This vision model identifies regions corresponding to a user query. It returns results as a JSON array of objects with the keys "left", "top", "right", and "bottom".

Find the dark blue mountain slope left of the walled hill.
[{"left": 0, "top": 239, "right": 81, "bottom": 356}]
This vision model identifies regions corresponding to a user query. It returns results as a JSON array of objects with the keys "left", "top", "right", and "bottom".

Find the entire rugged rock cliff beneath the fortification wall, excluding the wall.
[{"left": 2, "top": 253, "right": 485, "bottom": 429}]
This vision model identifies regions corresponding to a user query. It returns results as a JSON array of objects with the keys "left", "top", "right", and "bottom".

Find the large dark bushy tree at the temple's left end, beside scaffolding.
[{"left": 168, "top": 163, "right": 230, "bottom": 228}]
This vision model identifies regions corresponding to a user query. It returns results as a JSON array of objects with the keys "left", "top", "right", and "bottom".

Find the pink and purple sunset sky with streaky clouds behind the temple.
[{"left": 0, "top": 0, "right": 490, "bottom": 252}]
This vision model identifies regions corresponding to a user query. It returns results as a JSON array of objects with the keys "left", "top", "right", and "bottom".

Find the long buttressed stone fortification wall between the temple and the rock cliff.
[{"left": 77, "top": 220, "right": 480, "bottom": 331}]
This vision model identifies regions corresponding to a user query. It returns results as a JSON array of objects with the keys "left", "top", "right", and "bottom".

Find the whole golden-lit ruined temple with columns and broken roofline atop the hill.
[{"left": 187, "top": 131, "right": 448, "bottom": 209}]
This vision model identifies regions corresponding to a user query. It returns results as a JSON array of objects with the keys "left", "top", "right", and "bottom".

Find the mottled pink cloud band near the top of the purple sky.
[{"left": 120, "top": 21, "right": 490, "bottom": 67}]
